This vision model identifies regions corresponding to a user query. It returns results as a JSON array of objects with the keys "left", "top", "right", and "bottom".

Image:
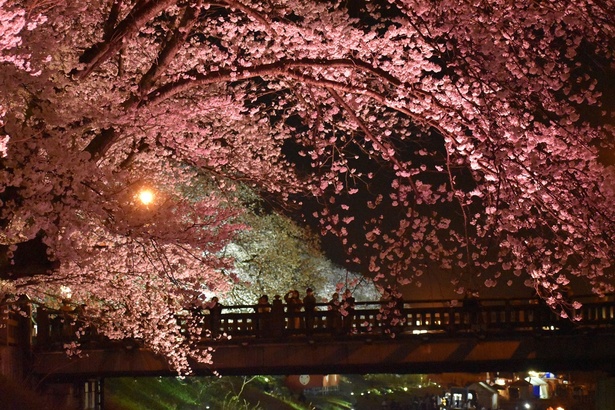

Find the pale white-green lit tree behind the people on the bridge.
[{"left": 222, "top": 190, "right": 379, "bottom": 305}]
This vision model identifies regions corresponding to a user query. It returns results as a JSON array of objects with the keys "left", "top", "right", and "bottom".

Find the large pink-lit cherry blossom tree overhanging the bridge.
[{"left": 0, "top": 0, "right": 615, "bottom": 372}]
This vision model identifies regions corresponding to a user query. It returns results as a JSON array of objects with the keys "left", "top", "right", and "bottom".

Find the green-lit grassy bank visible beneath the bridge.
[{"left": 105, "top": 374, "right": 438, "bottom": 410}]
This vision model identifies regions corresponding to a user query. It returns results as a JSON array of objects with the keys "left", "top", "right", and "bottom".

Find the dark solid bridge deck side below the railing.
[{"left": 32, "top": 332, "right": 615, "bottom": 378}]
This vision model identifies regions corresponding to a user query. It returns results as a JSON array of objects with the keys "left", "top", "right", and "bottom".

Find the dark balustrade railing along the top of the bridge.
[{"left": 26, "top": 297, "right": 615, "bottom": 347}]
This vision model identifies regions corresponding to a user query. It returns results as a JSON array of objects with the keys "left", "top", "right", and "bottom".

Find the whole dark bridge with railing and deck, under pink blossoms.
[{"left": 8, "top": 297, "right": 615, "bottom": 380}]
